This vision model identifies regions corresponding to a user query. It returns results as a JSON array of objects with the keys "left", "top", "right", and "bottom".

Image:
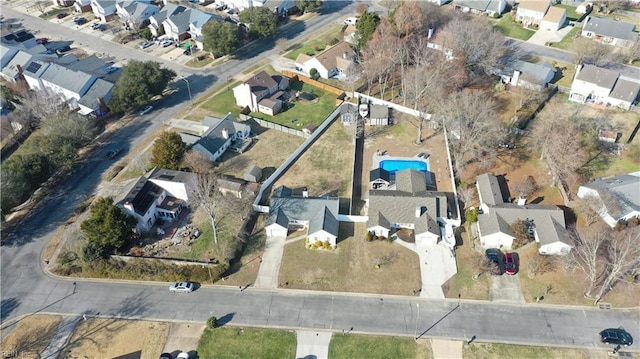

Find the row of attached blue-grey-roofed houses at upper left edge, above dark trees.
[{"left": 0, "top": 34, "right": 120, "bottom": 115}]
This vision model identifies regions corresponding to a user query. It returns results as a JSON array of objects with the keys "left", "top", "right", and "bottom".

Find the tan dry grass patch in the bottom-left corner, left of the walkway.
[{"left": 0, "top": 315, "right": 62, "bottom": 358}]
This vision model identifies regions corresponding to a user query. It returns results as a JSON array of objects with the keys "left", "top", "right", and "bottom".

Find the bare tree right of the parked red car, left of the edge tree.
[{"left": 560, "top": 230, "right": 608, "bottom": 298}]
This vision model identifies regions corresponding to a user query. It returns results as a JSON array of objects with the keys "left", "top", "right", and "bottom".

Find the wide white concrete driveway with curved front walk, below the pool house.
[{"left": 394, "top": 239, "right": 458, "bottom": 299}]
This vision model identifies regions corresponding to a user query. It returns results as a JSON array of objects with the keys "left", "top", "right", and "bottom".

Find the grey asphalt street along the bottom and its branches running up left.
[{"left": 0, "top": 2, "right": 640, "bottom": 349}]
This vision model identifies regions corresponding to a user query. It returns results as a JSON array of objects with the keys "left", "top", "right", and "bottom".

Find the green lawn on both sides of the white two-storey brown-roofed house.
[{"left": 203, "top": 81, "right": 336, "bottom": 129}]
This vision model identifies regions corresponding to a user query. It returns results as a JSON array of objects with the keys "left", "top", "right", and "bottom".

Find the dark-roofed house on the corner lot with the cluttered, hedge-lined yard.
[{"left": 116, "top": 168, "right": 196, "bottom": 233}]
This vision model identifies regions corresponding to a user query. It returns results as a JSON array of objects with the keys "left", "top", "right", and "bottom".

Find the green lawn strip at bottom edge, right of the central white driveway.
[{"left": 329, "top": 334, "right": 422, "bottom": 359}]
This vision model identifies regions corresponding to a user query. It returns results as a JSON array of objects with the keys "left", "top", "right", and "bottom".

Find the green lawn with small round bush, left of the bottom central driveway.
[{"left": 198, "top": 330, "right": 297, "bottom": 359}]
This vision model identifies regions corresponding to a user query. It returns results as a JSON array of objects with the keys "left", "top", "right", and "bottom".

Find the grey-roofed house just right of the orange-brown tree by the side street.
[{"left": 192, "top": 114, "right": 251, "bottom": 162}]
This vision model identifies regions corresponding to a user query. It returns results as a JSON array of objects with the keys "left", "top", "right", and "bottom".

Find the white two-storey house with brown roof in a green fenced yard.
[{"left": 233, "top": 71, "right": 289, "bottom": 116}]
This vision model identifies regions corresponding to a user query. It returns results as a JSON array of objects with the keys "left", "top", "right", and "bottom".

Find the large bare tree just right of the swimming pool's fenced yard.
[{"left": 439, "top": 89, "right": 504, "bottom": 173}]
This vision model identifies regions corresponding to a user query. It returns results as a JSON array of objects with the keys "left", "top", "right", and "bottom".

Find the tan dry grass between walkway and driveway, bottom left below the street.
[{"left": 65, "top": 318, "right": 169, "bottom": 359}]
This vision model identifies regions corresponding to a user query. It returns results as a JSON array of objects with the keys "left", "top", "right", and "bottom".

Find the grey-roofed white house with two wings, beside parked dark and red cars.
[{"left": 476, "top": 173, "right": 572, "bottom": 255}]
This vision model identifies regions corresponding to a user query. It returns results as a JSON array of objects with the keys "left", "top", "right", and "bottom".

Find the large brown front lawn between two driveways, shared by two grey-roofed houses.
[{"left": 279, "top": 223, "right": 421, "bottom": 295}]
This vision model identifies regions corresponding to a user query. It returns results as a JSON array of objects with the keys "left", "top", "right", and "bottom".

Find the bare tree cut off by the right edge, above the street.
[{"left": 595, "top": 227, "right": 640, "bottom": 303}]
